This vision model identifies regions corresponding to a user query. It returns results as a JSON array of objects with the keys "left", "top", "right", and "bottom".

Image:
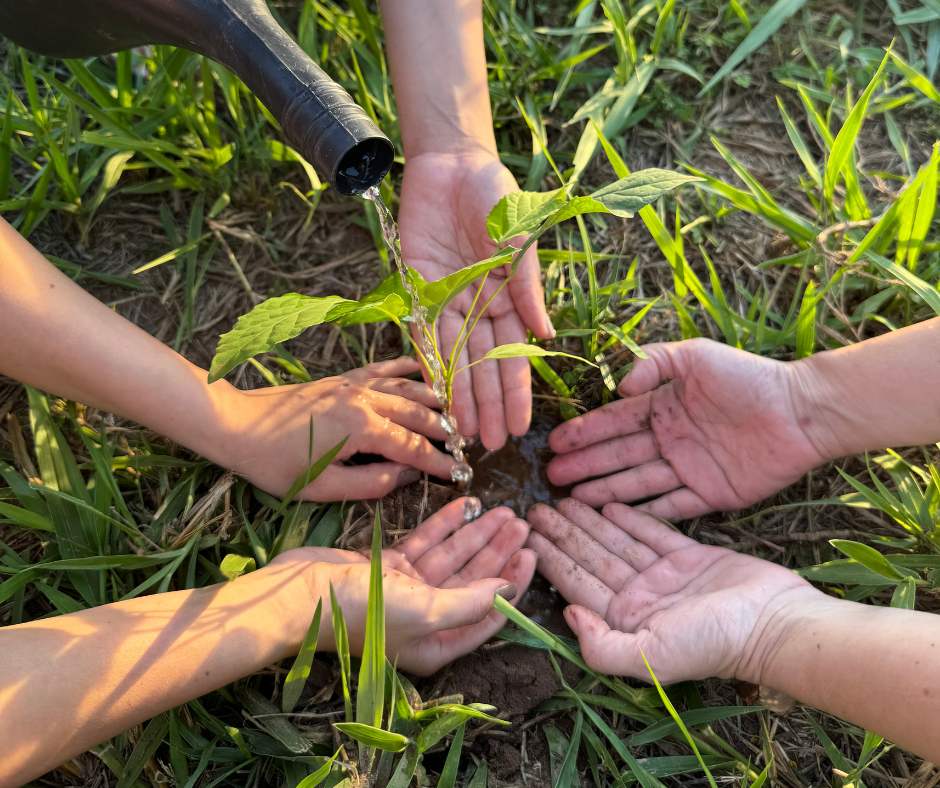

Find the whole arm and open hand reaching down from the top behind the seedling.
[{"left": 379, "top": 0, "right": 554, "bottom": 449}]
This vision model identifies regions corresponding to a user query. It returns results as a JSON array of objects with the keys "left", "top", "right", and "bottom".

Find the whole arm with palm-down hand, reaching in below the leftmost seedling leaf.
[{"left": 0, "top": 219, "right": 453, "bottom": 500}]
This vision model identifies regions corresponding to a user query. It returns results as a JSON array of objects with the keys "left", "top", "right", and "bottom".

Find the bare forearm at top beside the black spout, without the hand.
[{"left": 379, "top": 0, "right": 496, "bottom": 157}]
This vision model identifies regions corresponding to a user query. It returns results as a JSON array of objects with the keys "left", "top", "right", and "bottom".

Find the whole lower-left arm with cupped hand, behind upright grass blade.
[{"left": 0, "top": 499, "right": 535, "bottom": 788}]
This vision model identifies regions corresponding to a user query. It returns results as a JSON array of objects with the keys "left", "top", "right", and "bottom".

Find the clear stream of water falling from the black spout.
[{"left": 362, "top": 185, "right": 481, "bottom": 490}]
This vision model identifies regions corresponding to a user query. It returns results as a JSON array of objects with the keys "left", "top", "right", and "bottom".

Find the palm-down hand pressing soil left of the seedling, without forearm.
[{"left": 212, "top": 358, "right": 454, "bottom": 501}]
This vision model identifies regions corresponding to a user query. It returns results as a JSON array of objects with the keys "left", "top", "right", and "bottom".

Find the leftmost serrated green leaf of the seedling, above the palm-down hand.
[{"left": 209, "top": 293, "right": 357, "bottom": 383}]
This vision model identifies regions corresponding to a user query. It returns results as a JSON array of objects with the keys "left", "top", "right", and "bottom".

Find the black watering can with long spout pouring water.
[{"left": 0, "top": 0, "right": 394, "bottom": 194}]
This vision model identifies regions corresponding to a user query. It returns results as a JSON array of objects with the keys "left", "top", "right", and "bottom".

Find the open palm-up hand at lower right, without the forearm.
[{"left": 527, "top": 498, "right": 827, "bottom": 684}]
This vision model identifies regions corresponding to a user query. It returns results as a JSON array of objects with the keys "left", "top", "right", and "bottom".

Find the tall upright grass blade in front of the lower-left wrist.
[{"left": 356, "top": 506, "right": 385, "bottom": 728}]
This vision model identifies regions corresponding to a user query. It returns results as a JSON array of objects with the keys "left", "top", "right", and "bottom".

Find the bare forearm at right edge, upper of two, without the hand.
[{"left": 794, "top": 318, "right": 940, "bottom": 458}]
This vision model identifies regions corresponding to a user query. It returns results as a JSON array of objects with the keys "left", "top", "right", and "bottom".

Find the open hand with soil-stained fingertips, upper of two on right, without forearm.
[{"left": 548, "top": 339, "right": 831, "bottom": 521}]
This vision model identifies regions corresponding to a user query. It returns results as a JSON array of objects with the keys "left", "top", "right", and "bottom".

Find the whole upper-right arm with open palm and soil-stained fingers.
[{"left": 548, "top": 318, "right": 940, "bottom": 520}]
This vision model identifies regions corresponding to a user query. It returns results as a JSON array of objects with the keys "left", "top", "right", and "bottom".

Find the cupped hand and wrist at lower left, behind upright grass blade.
[{"left": 270, "top": 498, "right": 536, "bottom": 675}]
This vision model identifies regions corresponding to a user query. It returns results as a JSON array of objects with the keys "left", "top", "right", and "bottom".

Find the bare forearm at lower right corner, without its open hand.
[{"left": 760, "top": 597, "right": 940, "bottom": 762}]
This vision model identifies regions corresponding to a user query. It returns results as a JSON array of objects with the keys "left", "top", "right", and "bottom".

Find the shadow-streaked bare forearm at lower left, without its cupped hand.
[{"left": 0, "top": 567, "right": 313, "bottom": 788}]
